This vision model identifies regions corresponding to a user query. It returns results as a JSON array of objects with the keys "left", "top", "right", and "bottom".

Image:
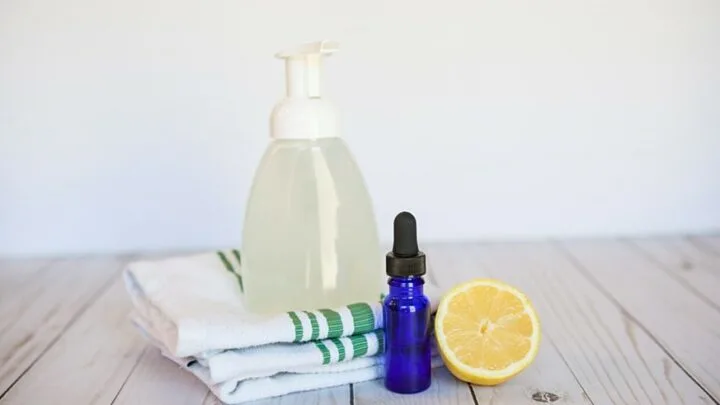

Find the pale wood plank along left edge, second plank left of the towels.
[{"left": 0, "top": 258, "right": 122, "bottom": 398}]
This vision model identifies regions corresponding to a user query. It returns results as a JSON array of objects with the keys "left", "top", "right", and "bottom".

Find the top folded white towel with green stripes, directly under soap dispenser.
[{"left": 123, "top": 250, "right": 440, "bottom": 356}]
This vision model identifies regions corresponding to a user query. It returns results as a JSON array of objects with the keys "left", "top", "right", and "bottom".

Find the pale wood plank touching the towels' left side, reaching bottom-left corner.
[{"left": 0, "top": 272, "right": 146, "bottom": 405}]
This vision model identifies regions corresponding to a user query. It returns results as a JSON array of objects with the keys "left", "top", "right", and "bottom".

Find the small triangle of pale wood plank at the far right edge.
[{"left": 629, "top": 238, "right": 720, "bottom": 311}]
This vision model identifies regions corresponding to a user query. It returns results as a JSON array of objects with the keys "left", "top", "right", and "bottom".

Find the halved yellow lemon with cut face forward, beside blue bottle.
[{"left": 435, "top": 279, "right": 540, "bottom": 385}]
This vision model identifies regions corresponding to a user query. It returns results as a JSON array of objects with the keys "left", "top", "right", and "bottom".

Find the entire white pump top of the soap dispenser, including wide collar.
[{"left": 271, "top": 41, "right": 339, "bottom": 139}]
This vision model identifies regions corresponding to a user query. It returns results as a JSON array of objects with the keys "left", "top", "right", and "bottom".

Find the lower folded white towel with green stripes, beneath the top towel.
[{"left": 135, "top": 312, "right": 442, "bottom": 404}]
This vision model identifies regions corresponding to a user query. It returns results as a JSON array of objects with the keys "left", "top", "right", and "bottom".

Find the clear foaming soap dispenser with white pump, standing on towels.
[{"left": 242, "top": 41, "right": 384, "bottom": 314}]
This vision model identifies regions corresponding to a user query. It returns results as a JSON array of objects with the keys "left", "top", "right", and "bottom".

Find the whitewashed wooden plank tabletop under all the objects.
[{"left": 0, "top": 236, "right": 720, "bottom": 405}]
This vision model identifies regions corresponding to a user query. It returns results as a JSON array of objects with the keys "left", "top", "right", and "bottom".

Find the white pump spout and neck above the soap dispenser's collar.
[{"left": 275, "top": 41, "right": 339, "bottom": 98}]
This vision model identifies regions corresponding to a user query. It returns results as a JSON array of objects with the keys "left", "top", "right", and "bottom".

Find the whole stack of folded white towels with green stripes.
[{"left": 123, "top": 250, "right": 441, "bottom": 404}]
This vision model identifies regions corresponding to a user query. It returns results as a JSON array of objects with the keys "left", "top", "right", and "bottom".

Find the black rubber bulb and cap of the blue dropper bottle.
[{"left": 385, "top": 211, "right": 425, "bottom": 277}]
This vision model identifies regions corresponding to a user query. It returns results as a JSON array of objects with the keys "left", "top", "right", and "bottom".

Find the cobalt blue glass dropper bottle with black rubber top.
[{"left": 383, "top": 212, "right": 431, "bottom": 394}]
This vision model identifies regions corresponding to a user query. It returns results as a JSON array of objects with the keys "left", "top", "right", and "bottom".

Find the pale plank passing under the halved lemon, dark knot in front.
[{"left": 425, "top": 244, "right": 590, "bottom": 405}]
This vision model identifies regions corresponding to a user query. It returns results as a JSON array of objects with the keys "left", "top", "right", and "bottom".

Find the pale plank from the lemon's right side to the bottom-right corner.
[{"left": 444, "top": 243, "right": 712, "bottom": 405}]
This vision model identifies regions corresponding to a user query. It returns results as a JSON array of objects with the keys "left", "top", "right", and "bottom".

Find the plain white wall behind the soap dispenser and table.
[{"left": 0, "top": 0, "right": 720, "bottom": 254}]
